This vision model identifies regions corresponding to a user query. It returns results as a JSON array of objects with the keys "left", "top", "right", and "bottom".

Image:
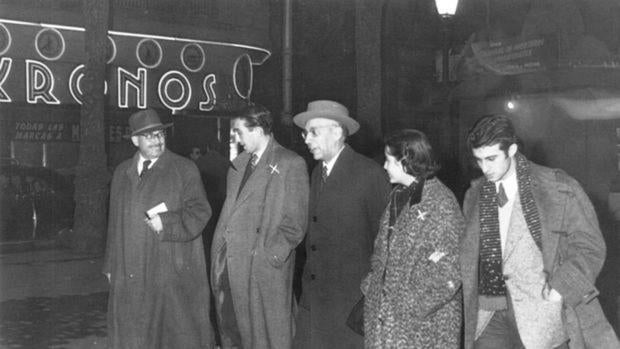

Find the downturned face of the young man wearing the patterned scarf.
[{"left": 473, "top": 143, "right": 517, "bottom": 182}]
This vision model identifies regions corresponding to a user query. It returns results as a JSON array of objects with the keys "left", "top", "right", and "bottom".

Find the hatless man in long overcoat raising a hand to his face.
[{"left": 211, "top": 102, "right": 308, "bottom": 349}]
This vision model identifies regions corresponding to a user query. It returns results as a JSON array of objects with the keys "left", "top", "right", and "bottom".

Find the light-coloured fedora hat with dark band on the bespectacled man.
[{"left": 293, "top": 100, "right": 360, "bottom": 135}]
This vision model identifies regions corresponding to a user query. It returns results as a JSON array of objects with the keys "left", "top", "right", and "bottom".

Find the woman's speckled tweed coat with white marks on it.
[{"left": 362, "top": 179, "right": 464, "bottom": 349}]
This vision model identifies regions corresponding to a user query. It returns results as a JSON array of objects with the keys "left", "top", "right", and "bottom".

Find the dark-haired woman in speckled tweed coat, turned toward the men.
[{"left": 362, "top": 130, "right": 464, "bottom": 349}]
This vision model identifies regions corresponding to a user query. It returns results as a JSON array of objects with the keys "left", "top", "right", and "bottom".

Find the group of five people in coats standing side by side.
[{"left": 104, "top": 100, "right": 620, "bottom": 349}]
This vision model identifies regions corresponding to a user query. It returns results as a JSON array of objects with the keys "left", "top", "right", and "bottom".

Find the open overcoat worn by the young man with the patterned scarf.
[{"left": 460, "top": 163, "right": 620, "bottom": 349}]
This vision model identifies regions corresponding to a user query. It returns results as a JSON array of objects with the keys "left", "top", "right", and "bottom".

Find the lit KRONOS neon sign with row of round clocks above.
[{"left": 0, "top": 18, "right": 271, "bottom": 114}]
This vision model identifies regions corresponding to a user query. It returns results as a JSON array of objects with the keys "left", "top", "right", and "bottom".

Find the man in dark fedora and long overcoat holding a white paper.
[{"left": 103, "top": 109, "right": 214, "bottom": 348}]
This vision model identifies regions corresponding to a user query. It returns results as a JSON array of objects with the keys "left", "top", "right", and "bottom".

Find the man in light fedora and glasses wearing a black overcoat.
[{"left": 293, "top": 100, "right": 390, "bottom": 348}]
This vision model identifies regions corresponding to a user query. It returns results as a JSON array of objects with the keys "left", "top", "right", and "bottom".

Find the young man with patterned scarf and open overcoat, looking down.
[{"left": 461, "top": 115, "right": 619, "bottom": 349}]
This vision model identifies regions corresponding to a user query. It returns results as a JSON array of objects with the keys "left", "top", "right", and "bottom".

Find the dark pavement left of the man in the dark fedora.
[{"left": 0, "top": 249, "right": 108, "bottom": 349}]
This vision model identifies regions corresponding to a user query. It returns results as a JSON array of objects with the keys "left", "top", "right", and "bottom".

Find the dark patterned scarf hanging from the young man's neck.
[{"left": 478, "top": 153, "right": 542, "bottom": 296}]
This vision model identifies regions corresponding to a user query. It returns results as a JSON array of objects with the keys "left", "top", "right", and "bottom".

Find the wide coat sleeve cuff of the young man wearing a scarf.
[{"left": 549, "top": 264, "right": 599, "bottom": 307}]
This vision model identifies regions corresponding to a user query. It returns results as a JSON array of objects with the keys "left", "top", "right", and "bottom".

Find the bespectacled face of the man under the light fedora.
[{"left": 302, "top": 118, "right": 342, "bottom": 161}]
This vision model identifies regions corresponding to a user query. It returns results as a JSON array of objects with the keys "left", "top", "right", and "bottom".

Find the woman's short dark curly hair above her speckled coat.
[{"left": 385, "top": 129, "right": 441, "bottom": 179}]
